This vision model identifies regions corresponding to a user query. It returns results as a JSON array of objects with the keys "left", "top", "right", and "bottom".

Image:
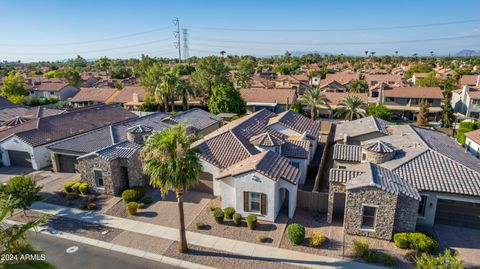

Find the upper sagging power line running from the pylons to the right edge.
[{"left": 187, "top": 19, "right": 480, "bottom": 32}]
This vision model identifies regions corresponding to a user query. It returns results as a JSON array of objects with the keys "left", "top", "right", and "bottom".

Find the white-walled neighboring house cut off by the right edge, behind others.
[{"left": 452, "top": 85, "right": 480, "bottom": 119}]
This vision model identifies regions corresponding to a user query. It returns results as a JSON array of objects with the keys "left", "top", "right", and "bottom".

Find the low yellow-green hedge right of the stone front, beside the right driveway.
[{"left": 393, "top": 232, "right": 438, "bottom": 253}]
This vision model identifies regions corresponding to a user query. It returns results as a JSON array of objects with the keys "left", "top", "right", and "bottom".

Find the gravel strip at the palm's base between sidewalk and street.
[{"left": 163, "top": 242, "right": 304, "bottom": 269}]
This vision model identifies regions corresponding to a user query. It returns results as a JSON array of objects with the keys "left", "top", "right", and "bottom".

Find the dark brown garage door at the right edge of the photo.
[{"left": 435, "top": 199, "right": 480, "bottom": 229}]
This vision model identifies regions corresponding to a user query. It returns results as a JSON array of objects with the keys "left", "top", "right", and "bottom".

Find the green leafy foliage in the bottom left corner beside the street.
[{"left": 0, "top": 196, "right": 55, "bottom": 269}]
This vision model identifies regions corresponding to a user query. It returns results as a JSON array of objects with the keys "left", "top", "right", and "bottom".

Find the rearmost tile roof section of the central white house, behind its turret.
[{"left": 268, "top": 110, "right": 321, "bottom": 139}]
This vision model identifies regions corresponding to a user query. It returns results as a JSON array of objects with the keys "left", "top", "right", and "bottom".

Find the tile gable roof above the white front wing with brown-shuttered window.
[{"left": 218, "top": 151, "right": 300, "bottom": 185}]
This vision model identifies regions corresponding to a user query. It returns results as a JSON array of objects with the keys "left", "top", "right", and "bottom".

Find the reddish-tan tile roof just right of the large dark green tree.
[{"left": 240, "top": 88, "right": 297, "bottom": 104}]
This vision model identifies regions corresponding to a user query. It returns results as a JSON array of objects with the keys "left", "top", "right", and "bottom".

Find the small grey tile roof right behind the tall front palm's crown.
[{"left": 161, "top": 108, "right": 222, "bottom": 131}]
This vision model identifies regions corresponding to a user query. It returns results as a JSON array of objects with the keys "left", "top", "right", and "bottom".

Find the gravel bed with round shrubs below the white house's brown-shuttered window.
[{"left": 187, "top": 199, "right": 282, "bottom": 245}]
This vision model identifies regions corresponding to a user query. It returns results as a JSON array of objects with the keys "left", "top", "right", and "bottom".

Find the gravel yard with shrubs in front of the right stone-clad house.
[{"left": 280, "top": 209, "right": 413, "bottom": 268}]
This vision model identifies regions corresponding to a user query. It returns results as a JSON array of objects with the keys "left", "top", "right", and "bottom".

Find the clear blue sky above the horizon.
[{"left": 0, "top": 0, "right": 480, "bottom": 62}]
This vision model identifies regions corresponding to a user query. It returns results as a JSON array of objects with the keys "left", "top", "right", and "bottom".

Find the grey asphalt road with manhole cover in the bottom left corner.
[{"left": 29, "top": 233, "right": 179, "bottom": 269}]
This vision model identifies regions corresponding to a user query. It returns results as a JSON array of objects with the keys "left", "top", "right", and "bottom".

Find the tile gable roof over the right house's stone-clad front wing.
[{"left": 347, "top": 160, "right": 420, "bottom": 201}]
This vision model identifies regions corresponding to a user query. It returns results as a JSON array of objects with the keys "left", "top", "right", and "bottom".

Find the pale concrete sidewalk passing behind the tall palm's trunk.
[{"left": 31, "top": 202, "right": 383, "bottom": 269}]
